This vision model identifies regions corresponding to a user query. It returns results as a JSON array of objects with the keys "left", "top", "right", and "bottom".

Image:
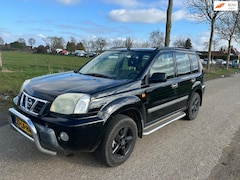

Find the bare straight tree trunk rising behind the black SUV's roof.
[{"left": 165, "top": 0, "right": 173, "bottom": 47}]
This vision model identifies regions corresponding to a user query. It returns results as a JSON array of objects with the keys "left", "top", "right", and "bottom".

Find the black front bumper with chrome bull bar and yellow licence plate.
[{"left": 9, "top": 108, "right": 103, "bottom": 155}]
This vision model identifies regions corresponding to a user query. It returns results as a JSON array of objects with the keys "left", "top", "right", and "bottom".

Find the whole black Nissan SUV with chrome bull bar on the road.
[{"left": 9, "top": 48, "right": 205, "bottom": 166}]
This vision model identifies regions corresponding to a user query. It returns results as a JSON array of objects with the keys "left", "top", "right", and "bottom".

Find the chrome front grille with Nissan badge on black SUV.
[{"left": 20, "top": 92, "right": 47, "bottom": 115}]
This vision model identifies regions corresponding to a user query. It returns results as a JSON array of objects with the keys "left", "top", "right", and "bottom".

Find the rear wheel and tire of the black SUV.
[{"left": 186, "top": 93, "right": 201, "bottom": 120}]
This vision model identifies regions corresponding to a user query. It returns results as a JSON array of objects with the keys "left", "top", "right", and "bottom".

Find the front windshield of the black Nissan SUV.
[{"left": 79, "top": 51, "right": 153, "bottom": 79}]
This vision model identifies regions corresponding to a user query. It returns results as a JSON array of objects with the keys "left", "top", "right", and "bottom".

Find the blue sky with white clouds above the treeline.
[{"left": 0, "top": 0, "right": 240, "bottom": 51}]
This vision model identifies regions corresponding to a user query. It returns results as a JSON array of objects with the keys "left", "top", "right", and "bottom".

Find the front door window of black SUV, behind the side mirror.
[{"left": 150, "top": 53, "right": 175, "bottom": 78}]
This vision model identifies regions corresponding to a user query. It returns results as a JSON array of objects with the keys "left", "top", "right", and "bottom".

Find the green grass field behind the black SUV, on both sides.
[{"left": 0, "top": 51, "right": 238, "bottom": 109}]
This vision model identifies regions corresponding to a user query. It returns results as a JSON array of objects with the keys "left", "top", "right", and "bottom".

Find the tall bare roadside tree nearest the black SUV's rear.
[{"left": 188, "top": 0, "right": 221, "bottom": 71}]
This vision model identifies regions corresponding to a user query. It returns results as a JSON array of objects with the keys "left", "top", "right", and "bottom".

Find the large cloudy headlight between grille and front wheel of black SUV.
[{"left": 50, "top": 93, "right": 90, "bottom": 114}]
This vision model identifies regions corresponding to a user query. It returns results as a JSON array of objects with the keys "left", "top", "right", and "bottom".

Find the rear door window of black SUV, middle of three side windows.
[{"left": 176, "top": 53, "right": 191, "bottom": 76}]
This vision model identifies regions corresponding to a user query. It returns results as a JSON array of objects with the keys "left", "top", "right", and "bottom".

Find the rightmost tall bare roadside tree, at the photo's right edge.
[{"left": 216, "top": 11, "right": 240, "bottom": 69}]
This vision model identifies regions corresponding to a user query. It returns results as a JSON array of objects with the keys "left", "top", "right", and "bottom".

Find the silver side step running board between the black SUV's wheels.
[{"left": 143, "top": 112, "right": 186, "bottom": 135}]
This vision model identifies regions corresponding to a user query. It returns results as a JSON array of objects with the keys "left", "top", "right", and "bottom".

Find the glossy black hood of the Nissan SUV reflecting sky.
[{"left": 24, "top": 72, "right": 132, "bottom": 101}]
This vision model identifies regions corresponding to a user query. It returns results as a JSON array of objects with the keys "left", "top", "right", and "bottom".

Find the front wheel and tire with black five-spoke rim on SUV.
[{"left": 96, "top": 115, "right": 137, "bottom": 167}]
